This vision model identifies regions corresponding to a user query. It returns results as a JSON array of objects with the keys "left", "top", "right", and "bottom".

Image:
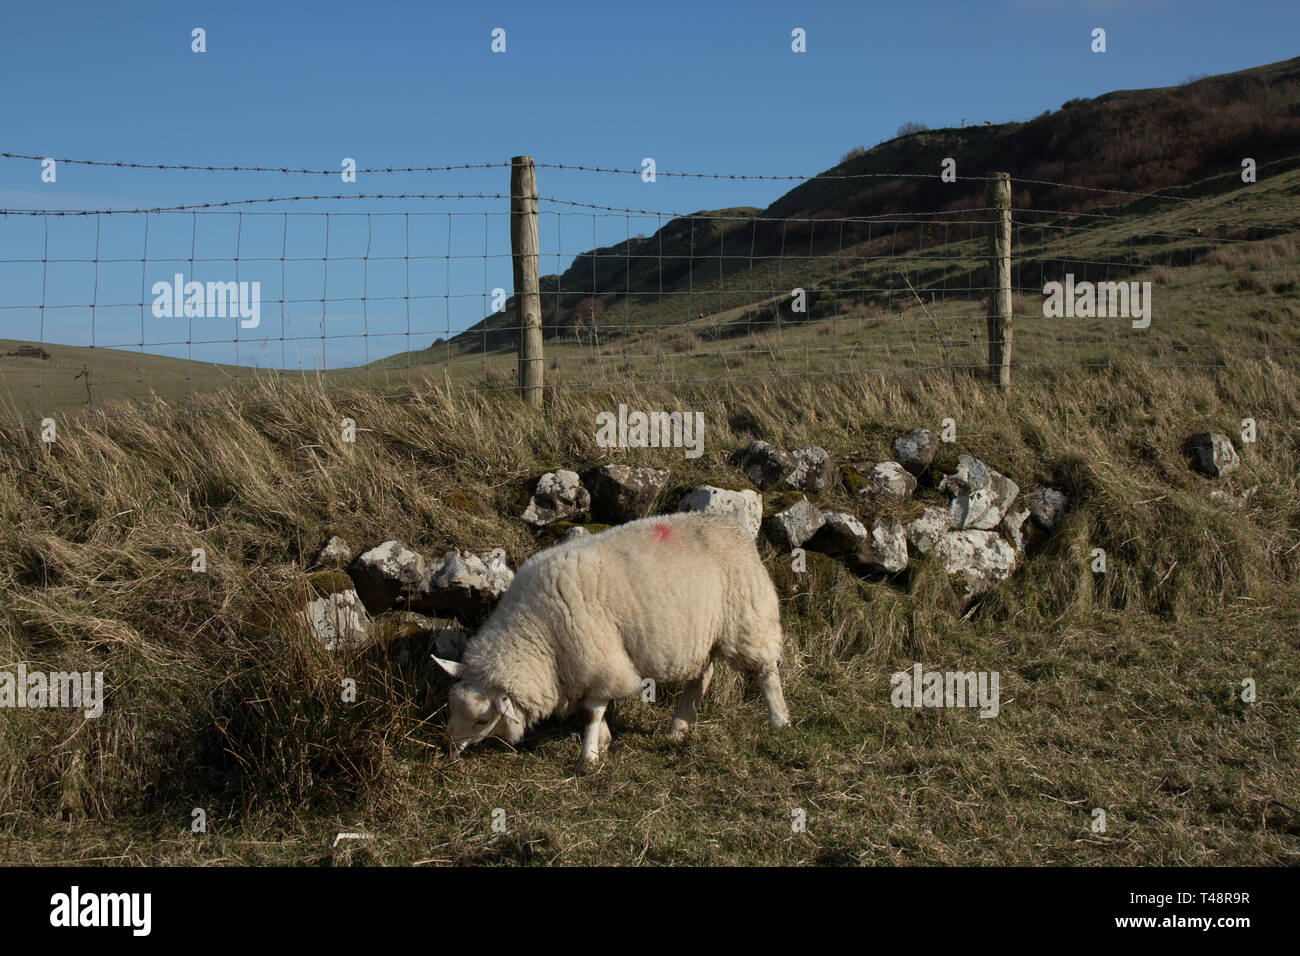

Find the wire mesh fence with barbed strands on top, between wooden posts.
[{"left": 0, "top": 153, "right": 1300, "bottom": 421}]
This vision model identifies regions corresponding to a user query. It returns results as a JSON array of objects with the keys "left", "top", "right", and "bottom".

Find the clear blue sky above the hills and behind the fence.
[{"left": 0, "top": 0, "right": 1300, "bottom": 367}]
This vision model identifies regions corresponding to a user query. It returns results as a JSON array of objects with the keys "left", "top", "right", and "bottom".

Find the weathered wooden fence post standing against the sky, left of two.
[{"left": 510, "top": 156, "right": 542, "bottom": 408}]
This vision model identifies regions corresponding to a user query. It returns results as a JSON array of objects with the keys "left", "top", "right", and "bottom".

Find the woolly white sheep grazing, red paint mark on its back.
[{"left": 434, "top": 512, "right": 790, "bottom": 770}]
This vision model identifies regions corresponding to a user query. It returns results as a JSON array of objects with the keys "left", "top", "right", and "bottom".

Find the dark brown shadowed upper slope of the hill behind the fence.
[{"left": 413, "top": 57, "right": 1300, "bottom": 367}]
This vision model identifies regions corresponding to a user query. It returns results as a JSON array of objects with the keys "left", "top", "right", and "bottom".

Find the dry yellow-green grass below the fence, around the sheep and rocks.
[{"left": 0, "top": 355, "right": 1300, "bottom": 865}]
